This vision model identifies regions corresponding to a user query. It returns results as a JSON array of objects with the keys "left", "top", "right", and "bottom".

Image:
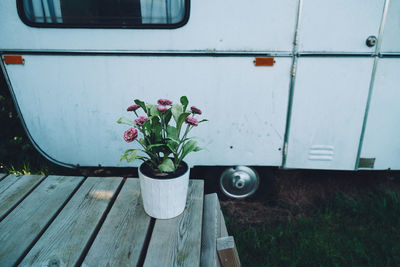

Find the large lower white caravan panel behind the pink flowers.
[{"left": 7, "top": 55, "right": 291, "bottom": 166}]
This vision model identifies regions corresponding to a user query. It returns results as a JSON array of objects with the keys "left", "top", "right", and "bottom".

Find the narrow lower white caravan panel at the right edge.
[{"left": 361, "top": 58, "right": 400, "bottom": 170}]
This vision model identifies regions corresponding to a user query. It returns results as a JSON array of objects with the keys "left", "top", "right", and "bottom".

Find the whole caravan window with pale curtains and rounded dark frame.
[{"left": 17, "top": 0, "right": 189, "bottom": 28}]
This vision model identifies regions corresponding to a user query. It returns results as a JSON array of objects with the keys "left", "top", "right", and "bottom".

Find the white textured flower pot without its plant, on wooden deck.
[{"left": 139, "top": 163, "right": 190, "bottom": 219}]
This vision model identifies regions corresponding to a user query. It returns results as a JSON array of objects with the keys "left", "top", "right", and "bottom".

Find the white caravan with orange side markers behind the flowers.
[{"left": 0, "top": 0, "right": 400, "bottom": 174}]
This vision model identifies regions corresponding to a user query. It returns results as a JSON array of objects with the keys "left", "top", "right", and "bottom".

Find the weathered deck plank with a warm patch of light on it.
[{"left": 21, "top": 177, "right": 122, "bottom": 266}]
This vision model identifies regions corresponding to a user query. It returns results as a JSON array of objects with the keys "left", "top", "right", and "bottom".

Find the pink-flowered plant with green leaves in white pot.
[{"left": 118, "top": 96, "right": 207, "bottom": 219}]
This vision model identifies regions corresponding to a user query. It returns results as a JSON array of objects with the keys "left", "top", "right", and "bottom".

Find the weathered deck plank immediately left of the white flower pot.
[{"left": 83, "top": 179, "right": 151, "bottom": 266}]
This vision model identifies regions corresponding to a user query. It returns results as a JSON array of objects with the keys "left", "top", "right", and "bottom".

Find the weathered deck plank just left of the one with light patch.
[{"left": 0, "top": 176, "right": 83, "bottom": 266}]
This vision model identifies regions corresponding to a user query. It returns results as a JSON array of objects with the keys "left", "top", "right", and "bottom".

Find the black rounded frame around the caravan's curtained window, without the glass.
[{"left": 16, "top": 0, "right": 190, "bottom": 30}]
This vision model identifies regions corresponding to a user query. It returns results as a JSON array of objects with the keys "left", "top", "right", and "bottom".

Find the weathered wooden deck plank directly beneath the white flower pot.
[{"left": 144, "top": 180, "right": 204, "bottom": 266}]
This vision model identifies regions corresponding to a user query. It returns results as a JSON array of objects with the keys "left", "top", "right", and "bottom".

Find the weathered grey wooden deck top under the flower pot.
[{"left": 0, "top": 174, "right": 204, "bottom": 266}]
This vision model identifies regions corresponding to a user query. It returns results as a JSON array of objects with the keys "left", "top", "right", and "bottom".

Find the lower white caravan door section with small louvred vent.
[{"left": 285, "top": 57, "right": 374, "bottom": 170}]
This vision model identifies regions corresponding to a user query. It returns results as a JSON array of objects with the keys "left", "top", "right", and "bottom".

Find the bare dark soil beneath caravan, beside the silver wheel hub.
[{"left": 220, "top": 169, "right": 400, "bottom": 227}]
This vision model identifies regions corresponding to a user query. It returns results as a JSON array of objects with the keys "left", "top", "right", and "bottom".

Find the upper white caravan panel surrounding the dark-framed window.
[{"left": 0, "top": 0, "right": 298, "bottom": 52}]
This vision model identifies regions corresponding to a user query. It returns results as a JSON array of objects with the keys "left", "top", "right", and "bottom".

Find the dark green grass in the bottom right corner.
[{"left": 227, "top": 191, "right": 400, "bottom": 266}]
